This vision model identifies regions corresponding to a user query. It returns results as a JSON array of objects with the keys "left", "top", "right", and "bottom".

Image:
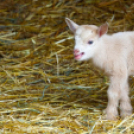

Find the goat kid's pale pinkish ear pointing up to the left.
[{"left": 65, "top": 18, "right": 79, "bottom": 33}]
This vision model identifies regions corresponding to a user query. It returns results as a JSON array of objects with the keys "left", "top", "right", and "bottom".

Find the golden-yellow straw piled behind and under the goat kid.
[{"left": 0, "top": 0, "right": 134, "bottom": 134}]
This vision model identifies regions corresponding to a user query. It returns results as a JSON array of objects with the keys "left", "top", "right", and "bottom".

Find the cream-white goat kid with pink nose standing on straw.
[{"left": 65, "top": 18, "right": 134, "bottom": 120}]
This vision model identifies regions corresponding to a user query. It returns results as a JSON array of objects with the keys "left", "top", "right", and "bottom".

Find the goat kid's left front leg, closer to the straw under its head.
[{"left": 105, "top": 74, "right": 124, "bottom": 120}]
